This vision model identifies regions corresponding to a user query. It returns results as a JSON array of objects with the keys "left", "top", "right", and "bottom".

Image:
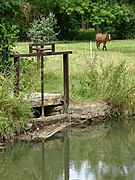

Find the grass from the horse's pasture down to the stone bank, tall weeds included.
[{"left": 14, "top": 40, "right": 135, "bottom": 111}]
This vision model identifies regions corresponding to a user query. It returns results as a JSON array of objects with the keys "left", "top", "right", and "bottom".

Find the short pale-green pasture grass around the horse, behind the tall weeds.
[{"left": 17, "top": 40, "right": 135, "bottom": 97}]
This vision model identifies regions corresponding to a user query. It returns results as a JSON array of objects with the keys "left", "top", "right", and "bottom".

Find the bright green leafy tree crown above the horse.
[{"left": 89, "top": 0, "right": 130, "bottom": 34}]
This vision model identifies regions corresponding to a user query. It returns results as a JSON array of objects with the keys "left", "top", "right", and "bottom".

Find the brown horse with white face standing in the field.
[{"left": 96, "top": 33, "right": 110, "bottom": 50}]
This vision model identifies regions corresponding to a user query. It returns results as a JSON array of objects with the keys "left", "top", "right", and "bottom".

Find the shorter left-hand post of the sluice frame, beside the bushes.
[{"left": 14, "top": 57, "right": 20, "bottom": 95}]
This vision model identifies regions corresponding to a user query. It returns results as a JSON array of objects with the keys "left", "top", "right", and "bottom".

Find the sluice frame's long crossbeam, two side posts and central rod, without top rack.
[{"left": 11, "top": 51, "right": 72, "bottom": 116}]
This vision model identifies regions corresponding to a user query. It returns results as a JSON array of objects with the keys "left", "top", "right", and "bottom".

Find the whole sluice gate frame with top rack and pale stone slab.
[{"left": 11, "top": 43, "right": 72, "bottom": 116}]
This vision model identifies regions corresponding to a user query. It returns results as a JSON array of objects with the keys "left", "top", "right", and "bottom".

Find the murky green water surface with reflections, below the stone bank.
[{"left": 0, "top": 126, "right": 135, "bottom": 180}]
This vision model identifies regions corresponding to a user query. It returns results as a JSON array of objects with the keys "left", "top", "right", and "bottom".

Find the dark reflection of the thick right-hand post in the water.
[{"left": 64, "top": 133, "right": 70, "bottom": 180}]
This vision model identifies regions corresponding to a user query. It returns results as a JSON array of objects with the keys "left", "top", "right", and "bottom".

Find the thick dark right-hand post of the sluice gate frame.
[{"left": 63, "top": 54, "right": 69, "bottom": 113}]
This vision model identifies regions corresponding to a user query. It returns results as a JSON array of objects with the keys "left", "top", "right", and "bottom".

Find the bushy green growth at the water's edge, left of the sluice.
[{"left": 0, "top": 70, "right": 32, "bottom": 136}]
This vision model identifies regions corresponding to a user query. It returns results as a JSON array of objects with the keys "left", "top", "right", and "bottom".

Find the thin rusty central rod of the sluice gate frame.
[{"left": 41, "top": 55, "right": 44, "bottom": 116}]
